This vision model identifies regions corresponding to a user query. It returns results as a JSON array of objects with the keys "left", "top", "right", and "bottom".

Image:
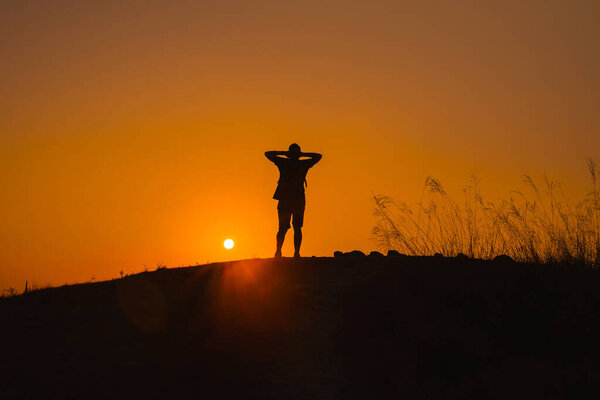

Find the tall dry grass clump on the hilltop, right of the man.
[{"left": 373, "top": 159, "right": 600, "bottom": 266}]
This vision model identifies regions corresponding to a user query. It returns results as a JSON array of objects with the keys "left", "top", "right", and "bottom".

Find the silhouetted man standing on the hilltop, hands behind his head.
[{"left": 265, "top": 143, "right": 323, "bottom": 258}]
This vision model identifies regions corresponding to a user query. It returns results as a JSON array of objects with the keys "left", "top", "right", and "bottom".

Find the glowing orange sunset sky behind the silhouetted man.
[{"left": 0, "top": 0, "right": 600, "bottom": 290}]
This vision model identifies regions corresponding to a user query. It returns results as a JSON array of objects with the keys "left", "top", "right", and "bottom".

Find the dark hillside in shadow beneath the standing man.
[{"left": 0, "top": 256, "right": 600, "bottom": 399}]
